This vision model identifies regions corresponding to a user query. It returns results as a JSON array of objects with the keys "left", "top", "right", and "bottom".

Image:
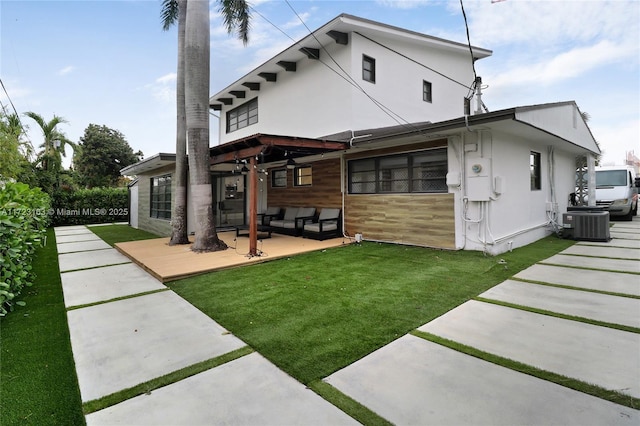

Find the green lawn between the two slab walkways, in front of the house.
[{"left": 169, "top": 237, "right": 573, "bottom": 385}]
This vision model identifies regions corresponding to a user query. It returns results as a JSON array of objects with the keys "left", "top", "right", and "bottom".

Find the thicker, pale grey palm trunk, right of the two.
[{"left": 185, "top": 0, "right": 227, "bottom": 252}]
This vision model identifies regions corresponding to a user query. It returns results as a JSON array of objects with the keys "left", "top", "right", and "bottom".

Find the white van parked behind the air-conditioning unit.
[{"left": 596, "top": 166, "right": 638, "bottom": 220}]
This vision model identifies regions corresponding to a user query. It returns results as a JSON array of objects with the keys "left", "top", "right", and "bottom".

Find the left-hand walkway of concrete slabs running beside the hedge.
[{"left": 55, "top": 226, "right": 357, "bottom": 425}]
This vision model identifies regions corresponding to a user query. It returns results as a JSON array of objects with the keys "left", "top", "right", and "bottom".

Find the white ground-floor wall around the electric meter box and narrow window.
[{"left": 449, "top": 131, "right": 575, "bottom": 255}]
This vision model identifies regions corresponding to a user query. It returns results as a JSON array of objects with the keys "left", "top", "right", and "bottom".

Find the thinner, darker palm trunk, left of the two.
[{"left": 169, "top": 0, "right": 189, "bottom": 246}]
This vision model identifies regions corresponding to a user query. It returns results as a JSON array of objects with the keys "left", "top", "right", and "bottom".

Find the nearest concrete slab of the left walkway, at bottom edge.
[{"left": 86, "top": 352, "right": 359, "bottom": 426}]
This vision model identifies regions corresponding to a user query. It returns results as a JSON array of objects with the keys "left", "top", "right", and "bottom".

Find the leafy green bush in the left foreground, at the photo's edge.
[{"left": 0, "top": 181, "right": 50, "bottom": 316}]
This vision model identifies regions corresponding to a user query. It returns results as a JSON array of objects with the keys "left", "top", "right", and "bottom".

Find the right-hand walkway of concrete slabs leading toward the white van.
[{"left": 325, "top": 218, "right": 640, "bottom": 425}]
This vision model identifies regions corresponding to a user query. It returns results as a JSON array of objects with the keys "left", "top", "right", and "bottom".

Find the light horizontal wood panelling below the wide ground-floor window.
[{"left": 345, "top": 194, "right": 455, "bottom": 249}]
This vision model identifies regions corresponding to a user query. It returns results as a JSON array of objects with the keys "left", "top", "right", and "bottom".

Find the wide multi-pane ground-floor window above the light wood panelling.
[{"left": 349, "top": 148, "right": 448, "bottom": 194}]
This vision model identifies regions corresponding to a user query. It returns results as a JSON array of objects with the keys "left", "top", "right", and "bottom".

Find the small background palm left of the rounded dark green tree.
[{"left": 24, "top": 111, "right": 76, "bottom": 173}]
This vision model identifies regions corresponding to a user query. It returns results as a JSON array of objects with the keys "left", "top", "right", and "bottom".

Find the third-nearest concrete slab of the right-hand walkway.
[{"left": 480, "top": 280, "right": 640, "bottom": 328}]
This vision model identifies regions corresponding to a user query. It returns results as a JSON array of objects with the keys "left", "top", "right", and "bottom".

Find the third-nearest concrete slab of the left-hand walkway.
[{"left": 60, "top": 263, "right": 166, "bottom": 307}]
